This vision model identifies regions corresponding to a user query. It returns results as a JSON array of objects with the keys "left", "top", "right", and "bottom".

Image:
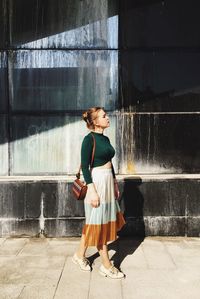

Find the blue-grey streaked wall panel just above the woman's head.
[{"left": 9, "top": 50, "right": 118, "bottom": 111}]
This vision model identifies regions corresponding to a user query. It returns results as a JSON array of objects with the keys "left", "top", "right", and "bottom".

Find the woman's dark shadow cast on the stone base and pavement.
[{"left": 88, "top": 177, "right": 145, "bottom": 269}]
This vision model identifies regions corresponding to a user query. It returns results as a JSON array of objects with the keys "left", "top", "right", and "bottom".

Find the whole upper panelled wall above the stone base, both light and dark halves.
[{"left": 0, "top": 0, "right": 200, "bottom": 175}]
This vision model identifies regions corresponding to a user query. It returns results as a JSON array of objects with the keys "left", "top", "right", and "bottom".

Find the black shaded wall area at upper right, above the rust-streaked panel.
[{"left": 119, "top": 0, "right": 200, "bottom": 112}]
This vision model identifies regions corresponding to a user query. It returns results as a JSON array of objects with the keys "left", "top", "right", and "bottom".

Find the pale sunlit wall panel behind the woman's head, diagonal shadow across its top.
[{"left": 11, "top": 116, "right": 116, "bottom": 175}]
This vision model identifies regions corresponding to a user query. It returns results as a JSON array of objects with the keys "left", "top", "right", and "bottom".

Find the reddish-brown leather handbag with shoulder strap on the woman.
[{"left": 72, "top": 134, "right": 96, "bottom": 200}]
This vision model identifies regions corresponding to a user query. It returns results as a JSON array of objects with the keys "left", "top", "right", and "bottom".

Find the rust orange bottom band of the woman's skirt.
[{"left": 82, "top": 212, "right": 125, "bottom": 246}]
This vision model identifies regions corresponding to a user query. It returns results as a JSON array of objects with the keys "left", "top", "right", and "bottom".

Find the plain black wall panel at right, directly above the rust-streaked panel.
[{"left": 120, "top": 49, "right": 200, "bottom": 112}]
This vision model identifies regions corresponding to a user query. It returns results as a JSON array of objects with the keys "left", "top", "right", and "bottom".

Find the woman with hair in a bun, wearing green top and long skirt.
[{"left": 72, "top": 107, "right": 125, "bottom": 278}]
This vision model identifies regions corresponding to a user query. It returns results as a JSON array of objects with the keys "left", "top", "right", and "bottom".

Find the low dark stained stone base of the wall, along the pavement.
[{"left": 0, "top": 175, "right": 200, "bottom": 237}]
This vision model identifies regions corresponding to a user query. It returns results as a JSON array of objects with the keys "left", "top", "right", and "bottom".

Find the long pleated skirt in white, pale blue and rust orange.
[{"left": 82, "top": 168, "right": 125, "bottom": 246}]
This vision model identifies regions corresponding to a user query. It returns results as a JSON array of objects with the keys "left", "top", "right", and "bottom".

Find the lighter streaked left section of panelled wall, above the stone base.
[{"left": 0, "top": 0, "right": 118, "bottom": 175}]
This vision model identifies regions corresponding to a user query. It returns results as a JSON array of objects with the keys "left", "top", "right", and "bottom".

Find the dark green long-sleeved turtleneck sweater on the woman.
[{"left": 81, "top": 132, "right": 115, "bottom": 184}]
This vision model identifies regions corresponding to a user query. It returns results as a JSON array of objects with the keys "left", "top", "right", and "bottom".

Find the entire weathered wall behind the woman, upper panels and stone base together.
[{"left": 0, "top": 0, "right": 200, "bottom": 236}]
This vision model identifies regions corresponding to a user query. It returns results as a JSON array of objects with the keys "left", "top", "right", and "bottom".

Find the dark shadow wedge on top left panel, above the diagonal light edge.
[{"left": 9, "top": 0, "right": 117, "bottom": 47}]
